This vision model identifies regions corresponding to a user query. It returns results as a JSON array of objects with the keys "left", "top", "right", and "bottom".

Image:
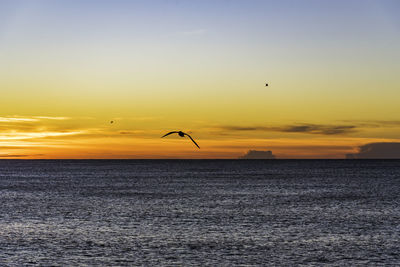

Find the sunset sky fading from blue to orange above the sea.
[{"left": 0, "top": 0, "right": 400, "bottom": 159}]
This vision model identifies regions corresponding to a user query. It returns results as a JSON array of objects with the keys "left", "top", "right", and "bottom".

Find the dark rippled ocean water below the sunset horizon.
[{"left": 0, "top": 160, "right": 400, "bottom": 266}]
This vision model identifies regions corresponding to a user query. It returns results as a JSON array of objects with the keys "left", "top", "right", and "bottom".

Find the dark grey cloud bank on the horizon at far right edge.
[{"left": 346, "top": 142, "right": 400, "bottom": 159}]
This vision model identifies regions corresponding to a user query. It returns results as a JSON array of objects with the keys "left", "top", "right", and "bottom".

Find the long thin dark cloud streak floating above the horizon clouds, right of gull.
[{"left": 219, "top": 124, "right": 357, "bottom": 135}]
